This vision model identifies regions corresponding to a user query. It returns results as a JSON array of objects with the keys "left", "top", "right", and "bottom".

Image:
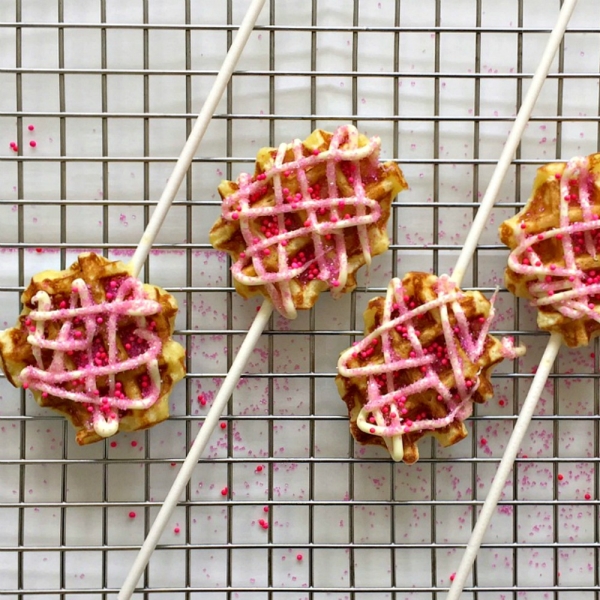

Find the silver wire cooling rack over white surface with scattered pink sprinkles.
[{"left": 0, "top": 0, "right": 600, "bottom": 600}]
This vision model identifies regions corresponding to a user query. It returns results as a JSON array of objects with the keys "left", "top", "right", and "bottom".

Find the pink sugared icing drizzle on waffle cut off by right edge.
[{"left": 508, "top": 157, "right": 600, "bottom": 322}]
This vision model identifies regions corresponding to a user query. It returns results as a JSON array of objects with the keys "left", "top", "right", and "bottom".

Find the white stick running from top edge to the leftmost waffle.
[{"left": 129, "top": 0, "right": 265, "bottom": 277}]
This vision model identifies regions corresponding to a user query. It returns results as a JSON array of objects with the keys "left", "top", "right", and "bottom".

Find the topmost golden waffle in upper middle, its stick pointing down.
[{"left": 210, "top": 126, "right": 407, "bottom": 318}]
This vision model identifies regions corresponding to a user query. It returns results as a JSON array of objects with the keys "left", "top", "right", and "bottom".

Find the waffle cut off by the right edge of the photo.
[{"left": 499, "top": 154, "right": 600, "bottom": 347}]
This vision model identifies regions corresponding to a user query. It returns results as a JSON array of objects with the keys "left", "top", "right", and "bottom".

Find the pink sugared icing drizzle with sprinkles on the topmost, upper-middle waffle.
[{"left": 222, "top": 125, "right": 381, "bottom": 318}]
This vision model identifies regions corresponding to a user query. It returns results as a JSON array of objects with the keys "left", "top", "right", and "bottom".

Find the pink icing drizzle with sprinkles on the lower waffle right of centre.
[{"left": 338, "top": 275, "right": 521, "bottom": 461}]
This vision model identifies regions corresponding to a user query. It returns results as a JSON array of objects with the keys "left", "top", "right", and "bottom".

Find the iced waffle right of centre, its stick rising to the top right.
[{"left": 336, "top": 272, "right": 522, "bottom": 463}]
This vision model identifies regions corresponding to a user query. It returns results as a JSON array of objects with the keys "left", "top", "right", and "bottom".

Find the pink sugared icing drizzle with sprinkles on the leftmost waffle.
[{"left": 20, "top": 277, "right": 162, "bottom": 437}]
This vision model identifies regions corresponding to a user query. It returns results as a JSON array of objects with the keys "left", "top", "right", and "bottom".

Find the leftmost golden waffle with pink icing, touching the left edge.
[{"left": 0, "top": 253, "right": 185, "bottom": 444}]
